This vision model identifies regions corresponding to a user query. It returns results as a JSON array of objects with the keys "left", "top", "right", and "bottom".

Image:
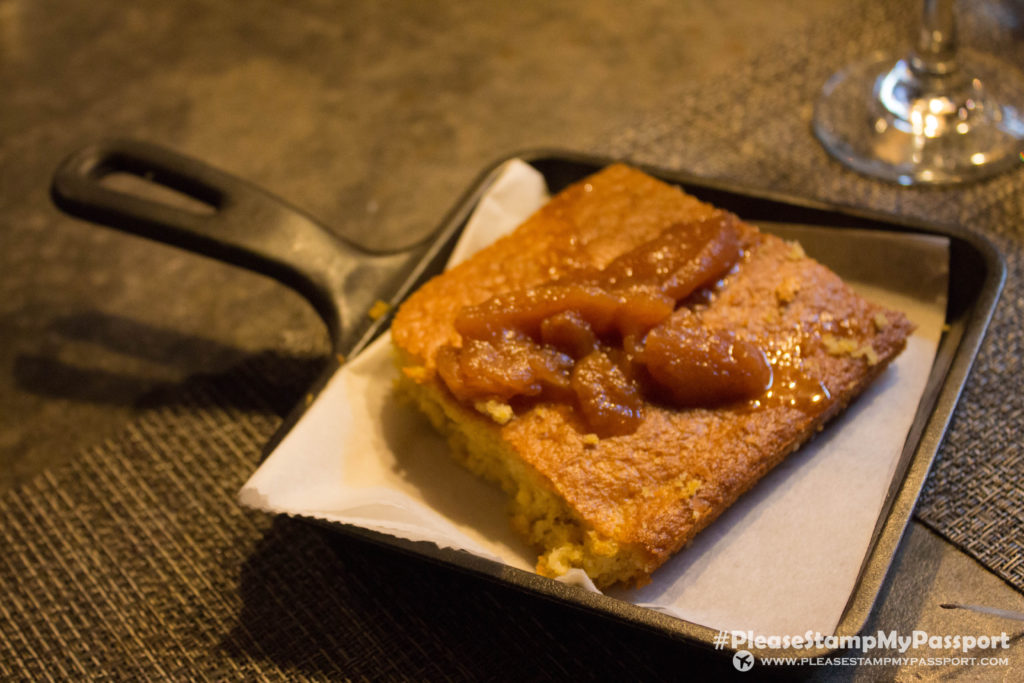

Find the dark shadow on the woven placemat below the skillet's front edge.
[{"left": 221, "top": 518, "right": 757, "bottom": 680}]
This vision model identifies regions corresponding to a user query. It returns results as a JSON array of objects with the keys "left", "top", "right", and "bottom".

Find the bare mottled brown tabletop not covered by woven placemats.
[{"left": 0, "top": 0, "right": 1024, "bottom": 679}]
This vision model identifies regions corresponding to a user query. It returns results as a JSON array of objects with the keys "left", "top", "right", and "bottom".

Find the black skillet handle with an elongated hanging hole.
[{"left": 50, "top": 140, "right": 408, "bottom": 353}]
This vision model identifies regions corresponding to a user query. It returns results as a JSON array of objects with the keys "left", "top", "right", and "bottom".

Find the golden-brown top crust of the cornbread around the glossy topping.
[{"left": 391, "top": 165, "right": 912, "bottom": 573}]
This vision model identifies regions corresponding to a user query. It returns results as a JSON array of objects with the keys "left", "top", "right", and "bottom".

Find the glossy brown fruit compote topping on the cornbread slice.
[{"left": 436, "top": 212, "right": 830, "bottom": 437}]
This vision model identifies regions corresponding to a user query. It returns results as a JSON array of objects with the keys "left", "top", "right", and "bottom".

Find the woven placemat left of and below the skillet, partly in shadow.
[{"left": 0, "top": 354, "right": 731, "bottom": 681}]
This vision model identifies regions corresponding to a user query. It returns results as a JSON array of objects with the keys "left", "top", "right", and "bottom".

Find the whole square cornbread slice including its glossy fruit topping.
[{"left": 391, "top": 165, "right": 912, "bottom": 587}]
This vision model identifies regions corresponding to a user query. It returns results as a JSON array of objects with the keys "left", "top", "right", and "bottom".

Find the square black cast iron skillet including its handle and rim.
[{"left": 51, "top": 140, "right": 1006, "bottom": 656}]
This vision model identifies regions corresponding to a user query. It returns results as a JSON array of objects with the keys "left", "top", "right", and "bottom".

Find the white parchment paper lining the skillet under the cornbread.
[{"left": 239, "top": 161, "right": 948, "bottom": 635}]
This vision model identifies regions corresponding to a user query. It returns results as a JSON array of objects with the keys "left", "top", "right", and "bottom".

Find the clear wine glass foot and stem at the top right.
[{"left": 814, "top": 0, "right": 1024, "bottom": 185}]
